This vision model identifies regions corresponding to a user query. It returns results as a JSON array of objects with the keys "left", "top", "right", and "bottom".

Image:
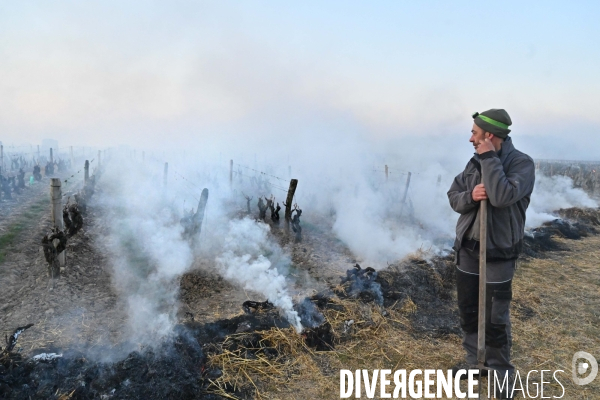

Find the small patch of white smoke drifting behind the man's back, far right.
[{"left": 525, "top": 174, "right": 598, "bottom": 229}]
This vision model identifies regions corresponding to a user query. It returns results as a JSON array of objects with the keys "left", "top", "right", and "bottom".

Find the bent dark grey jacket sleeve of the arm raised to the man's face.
[{"left": 480, "top": 152, "right": 535, "bottom": 208}]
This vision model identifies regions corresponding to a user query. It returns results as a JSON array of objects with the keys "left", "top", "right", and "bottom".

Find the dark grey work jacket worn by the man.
[{"left": 448, "top": 137, "right": 535, "bottom": 260}]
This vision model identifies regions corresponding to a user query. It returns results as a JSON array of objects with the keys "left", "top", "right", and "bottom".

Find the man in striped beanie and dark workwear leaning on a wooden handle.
[{"left": 448, "top": 109, "right": 535, "bottom": 394}]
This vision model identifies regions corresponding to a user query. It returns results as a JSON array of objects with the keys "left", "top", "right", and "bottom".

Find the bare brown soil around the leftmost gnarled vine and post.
[{"left": 0, "top": 182, "right": 123, "bottom": 352}]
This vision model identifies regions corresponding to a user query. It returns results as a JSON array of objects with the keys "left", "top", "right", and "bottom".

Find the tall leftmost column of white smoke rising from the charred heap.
[{"left": 99, "top": 159, "right": 192, "bottom": 344}]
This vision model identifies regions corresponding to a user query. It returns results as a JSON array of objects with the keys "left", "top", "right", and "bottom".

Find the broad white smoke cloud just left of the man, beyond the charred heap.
[{"left": 326, "top": 163, "right": 458, "bottom": 269}]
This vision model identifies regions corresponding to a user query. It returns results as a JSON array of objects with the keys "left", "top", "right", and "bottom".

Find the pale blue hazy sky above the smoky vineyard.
[{"left": 0, "top": 0, "right": 600, "bottom": 159}]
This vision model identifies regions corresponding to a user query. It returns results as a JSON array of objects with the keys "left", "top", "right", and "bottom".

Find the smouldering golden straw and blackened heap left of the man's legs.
[{"left": 208, "top": 258, "right": 459, "bottom": 398}]
